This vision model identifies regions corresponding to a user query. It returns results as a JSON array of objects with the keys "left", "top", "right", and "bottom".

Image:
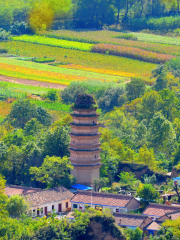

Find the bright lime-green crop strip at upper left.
[{"left": 12, "top": 35, "right": 92, "bottom": 51}]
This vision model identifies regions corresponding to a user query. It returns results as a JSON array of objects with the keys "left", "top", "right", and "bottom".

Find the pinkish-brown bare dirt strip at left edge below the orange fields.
[{"left": 0, "top": 75, "right": 67, "bottom": 89}]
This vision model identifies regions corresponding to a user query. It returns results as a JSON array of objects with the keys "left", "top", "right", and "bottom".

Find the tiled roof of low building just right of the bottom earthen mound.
[{"left": 114, "top": 213, "right": 148, "bottom": 227}]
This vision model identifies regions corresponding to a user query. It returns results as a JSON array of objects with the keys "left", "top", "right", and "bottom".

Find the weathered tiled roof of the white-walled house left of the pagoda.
[{"left": 24, "top": 187, "right": 74, "bottom": 206}]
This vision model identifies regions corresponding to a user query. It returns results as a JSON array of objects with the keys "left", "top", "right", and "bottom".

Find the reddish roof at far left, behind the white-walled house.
[{"left": 5, "top": 185, "right": 41, "bottom": 197}]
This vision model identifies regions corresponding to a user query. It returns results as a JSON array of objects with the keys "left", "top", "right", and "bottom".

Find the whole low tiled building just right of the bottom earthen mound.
[{"left": 114, "top": 213, "right": 153, "bottom": 230}]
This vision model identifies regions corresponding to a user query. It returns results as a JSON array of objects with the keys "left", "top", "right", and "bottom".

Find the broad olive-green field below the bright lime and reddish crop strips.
[{"left": 2, "top": 41, "right": 156, "bottom": 75}]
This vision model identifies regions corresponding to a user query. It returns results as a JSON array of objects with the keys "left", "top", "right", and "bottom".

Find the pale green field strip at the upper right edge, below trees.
[{"left": 132, "top": 32, "right": 180, "bottom": 46}]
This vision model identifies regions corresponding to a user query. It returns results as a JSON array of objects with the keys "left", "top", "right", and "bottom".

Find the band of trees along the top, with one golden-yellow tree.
[{"left": 0, "top": 0, "right": 180, "bottom": 31}]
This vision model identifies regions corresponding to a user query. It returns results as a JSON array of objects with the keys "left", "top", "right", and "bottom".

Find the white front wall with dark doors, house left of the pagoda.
[{"left": 30, "top": 199, "right": 71, "bottom": 217}]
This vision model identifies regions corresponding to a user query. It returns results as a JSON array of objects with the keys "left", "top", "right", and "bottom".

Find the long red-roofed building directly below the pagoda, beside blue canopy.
[{"left": 71, "top": 191, "right": 140, "bottom": 212}]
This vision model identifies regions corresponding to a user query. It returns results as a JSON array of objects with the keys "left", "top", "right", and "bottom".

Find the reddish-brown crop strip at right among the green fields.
[{"left": 91, "top": 43, "right": 175, "bottom": 63}]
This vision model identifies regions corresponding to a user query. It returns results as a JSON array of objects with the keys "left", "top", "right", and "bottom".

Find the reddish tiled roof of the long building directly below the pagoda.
[{"left": 71, "top": 191, "right": 136, "bottom": 207}]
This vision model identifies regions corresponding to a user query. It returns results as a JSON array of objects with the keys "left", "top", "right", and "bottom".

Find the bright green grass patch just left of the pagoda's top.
[{"left": 31, "top": 100, "right": 70, "bottom": 113}]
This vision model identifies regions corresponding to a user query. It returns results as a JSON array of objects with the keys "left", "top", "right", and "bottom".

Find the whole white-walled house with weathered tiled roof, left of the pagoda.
[{"left": 23, "top": 187, "right": 74, "bottom": 216}]
